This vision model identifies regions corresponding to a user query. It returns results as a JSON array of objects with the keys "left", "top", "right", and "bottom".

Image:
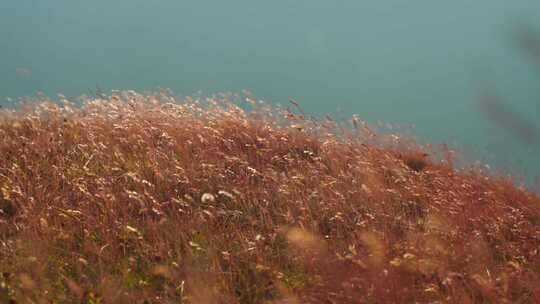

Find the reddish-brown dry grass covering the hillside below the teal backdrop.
[{"left": 0, "top": 92, "right": 540, "bottom": 303}]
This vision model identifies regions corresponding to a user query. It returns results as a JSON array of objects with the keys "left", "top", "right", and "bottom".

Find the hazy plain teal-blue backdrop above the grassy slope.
[{"left": 0, "top": 0, "right": 540, "bottom": 188}]
